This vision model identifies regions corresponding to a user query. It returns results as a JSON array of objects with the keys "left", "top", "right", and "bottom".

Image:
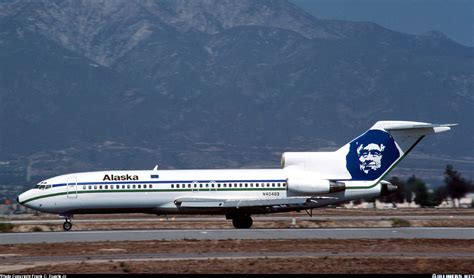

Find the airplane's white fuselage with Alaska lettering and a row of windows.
[{"left": 18, "top": 169, "right": 381, "bottom": 215}]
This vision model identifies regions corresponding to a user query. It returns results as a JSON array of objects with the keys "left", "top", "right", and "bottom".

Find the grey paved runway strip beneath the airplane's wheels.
[{"left": 0, "top": 227, "right": 474, "bottom": 245}]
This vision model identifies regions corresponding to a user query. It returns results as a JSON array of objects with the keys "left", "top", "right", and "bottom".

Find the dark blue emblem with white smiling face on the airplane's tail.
[{"left": 346, "top": 130, "right": 400, "bottom": 180}]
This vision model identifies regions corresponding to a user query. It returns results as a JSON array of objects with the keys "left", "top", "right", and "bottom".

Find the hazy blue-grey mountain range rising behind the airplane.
[{"left": 0, "top": 0, "right": 474, "bottom": 200}]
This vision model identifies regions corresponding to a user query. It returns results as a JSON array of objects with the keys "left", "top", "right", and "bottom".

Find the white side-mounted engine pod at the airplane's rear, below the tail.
[{"left": 288, "top": 178, "right": 346, "bottom": 196}]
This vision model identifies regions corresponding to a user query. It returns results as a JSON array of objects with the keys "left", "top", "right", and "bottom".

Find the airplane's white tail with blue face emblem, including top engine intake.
[{"left": 283, "top": 121, "right": 455, "bottom": 181}]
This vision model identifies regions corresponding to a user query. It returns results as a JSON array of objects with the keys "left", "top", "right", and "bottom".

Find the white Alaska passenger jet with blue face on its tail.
[{"left": 17, "top": 121, "right": 456, "bottom": 231}]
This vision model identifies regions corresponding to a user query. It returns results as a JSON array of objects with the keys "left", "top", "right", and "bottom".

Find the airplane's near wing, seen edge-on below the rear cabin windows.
[{"left": 174, "top": 196, "right": 336, "bottom": 208}]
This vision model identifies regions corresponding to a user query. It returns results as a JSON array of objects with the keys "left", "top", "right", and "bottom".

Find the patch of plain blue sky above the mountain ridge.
[{"left": 291, "top": 0, "right": 474, "bottom": 46}]
